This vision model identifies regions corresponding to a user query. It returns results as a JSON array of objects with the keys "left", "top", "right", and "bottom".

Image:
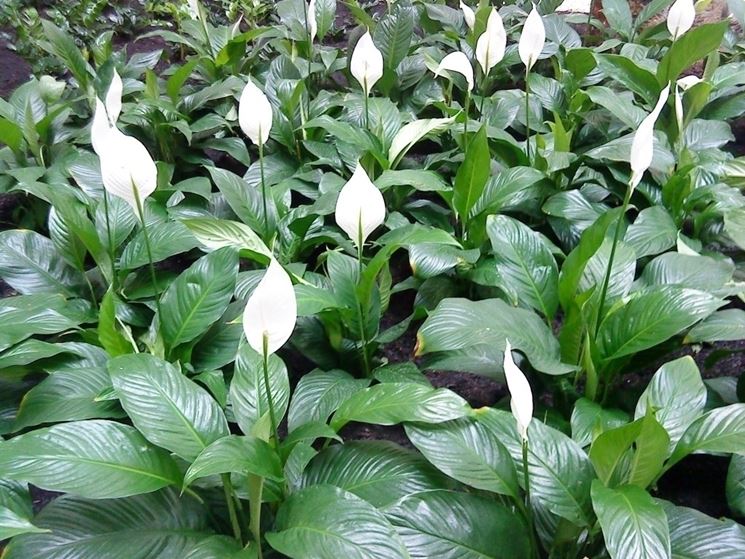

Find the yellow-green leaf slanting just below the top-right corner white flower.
[{"left": 657, "top": 21, "right": 729, "bottom": 86}]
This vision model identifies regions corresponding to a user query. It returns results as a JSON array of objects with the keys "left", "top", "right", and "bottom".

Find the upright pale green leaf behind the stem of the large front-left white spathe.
[{"left": 230, "top": 343, "right": 290, "bottom": 439}]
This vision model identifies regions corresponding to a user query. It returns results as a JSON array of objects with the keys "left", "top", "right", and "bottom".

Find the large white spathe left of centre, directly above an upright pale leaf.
[{"left": 243, "top": 258, "right": 297, "bottom": 355}]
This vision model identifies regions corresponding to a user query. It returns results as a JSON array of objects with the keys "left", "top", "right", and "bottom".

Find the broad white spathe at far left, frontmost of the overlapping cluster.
[{"left": 94, "top": 129, "right": 158, "bottom": 217}]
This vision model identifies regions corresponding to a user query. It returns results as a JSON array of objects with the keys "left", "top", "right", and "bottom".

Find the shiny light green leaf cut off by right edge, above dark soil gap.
[{"left": 670, "top": 404, "right": 745, "bottom": 463}]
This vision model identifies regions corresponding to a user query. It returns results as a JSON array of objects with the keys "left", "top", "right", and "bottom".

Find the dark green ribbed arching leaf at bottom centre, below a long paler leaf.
[{"left": 300, "top": 441, "right": 448, "bottom": 508}]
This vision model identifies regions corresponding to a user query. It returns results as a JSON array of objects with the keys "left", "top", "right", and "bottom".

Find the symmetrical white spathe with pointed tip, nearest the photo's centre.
[{"left": 334, "top": 163, "right": 385, "bottom": 248}]
